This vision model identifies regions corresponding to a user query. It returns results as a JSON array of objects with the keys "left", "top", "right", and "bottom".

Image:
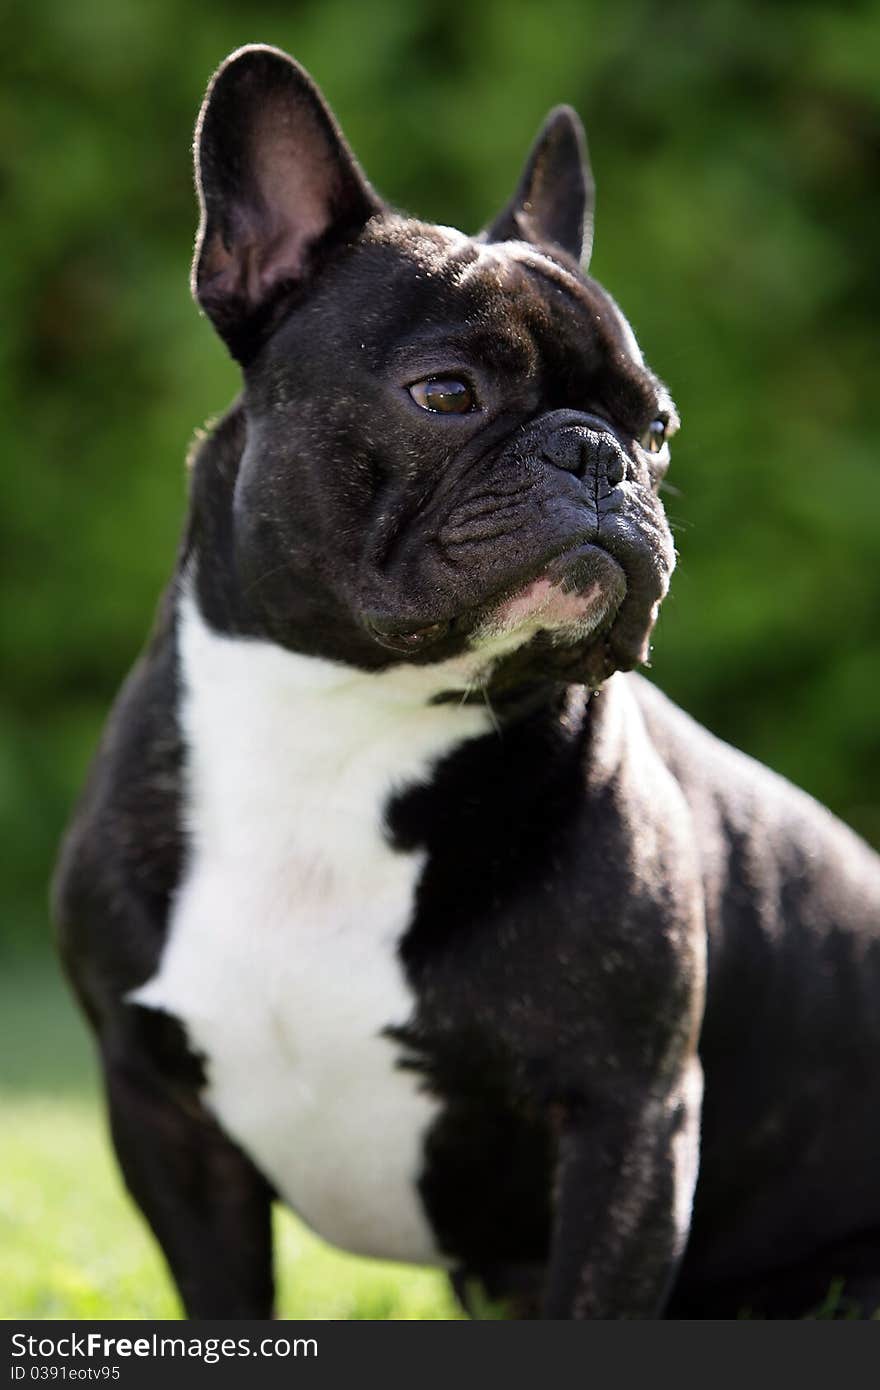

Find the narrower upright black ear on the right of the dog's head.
[{"left": 481, "top": 106, "right": 595, "bottom": 271}]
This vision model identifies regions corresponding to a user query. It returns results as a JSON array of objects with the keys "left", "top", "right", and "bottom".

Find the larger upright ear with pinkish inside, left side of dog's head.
[{"left": 192, "top": 44, "right": 382, "bottom": 363}]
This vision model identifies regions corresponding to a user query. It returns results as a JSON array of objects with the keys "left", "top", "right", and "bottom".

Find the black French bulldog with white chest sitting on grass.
[{"left": 54, "top": 46, "right": 880, "bottom": 1319}]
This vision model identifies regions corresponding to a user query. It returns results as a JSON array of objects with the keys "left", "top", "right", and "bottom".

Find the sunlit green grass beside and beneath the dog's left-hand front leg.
[{"left": 0, "top": 962, "right": 457, "bottom": 1319}]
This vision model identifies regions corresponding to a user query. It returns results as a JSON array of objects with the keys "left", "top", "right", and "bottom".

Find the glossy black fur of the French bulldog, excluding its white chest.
[{"left": 56, "top": 49, "right": 880, "bottom": 1318}]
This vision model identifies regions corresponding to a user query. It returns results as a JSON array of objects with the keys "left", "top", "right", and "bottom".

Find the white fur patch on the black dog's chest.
[{"left": 132, "top": 598, "right": 491, "bottom": 1262}]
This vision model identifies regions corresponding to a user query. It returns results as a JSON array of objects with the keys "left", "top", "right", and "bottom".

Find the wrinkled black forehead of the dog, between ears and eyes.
[{"left": 364, "top": 218, "right": 644, "bottom": 374}]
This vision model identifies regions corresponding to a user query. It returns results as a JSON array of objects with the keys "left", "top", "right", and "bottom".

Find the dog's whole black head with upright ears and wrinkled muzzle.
[{"left": 193, "top": 49, "right": 676, "bottom": 688}]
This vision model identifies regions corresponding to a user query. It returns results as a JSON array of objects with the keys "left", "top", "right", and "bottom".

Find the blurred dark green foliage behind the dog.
[{"left": 0, "top": 0, "right": 880, "bottom": 941}]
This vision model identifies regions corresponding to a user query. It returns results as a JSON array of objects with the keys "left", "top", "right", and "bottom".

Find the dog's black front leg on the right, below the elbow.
[{"left": 542, "top": 1058, "right": 702, "bottom": 1318}]
